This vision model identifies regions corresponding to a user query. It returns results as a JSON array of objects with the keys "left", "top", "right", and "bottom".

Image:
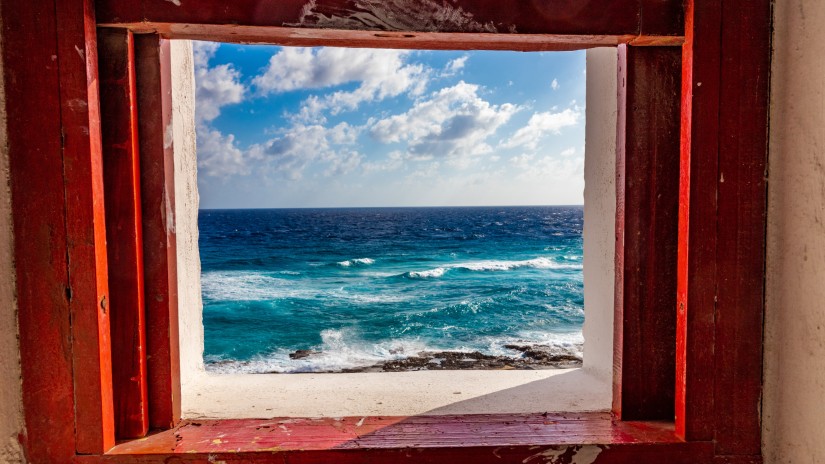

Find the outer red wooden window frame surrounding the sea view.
[{"left": 3, "top": 1, "right": 770, "bottom": 462}]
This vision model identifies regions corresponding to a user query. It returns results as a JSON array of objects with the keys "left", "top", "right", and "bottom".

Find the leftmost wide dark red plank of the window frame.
[{"left": 0, "top": 0, "right": 75, "bottom": 462}]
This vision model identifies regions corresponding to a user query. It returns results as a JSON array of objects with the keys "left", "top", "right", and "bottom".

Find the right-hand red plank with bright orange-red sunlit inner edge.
[{"left": 676, "top": 0, "right": 720, "bottom": 441}]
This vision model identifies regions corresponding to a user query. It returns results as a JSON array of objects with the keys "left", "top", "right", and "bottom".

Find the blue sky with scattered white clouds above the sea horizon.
[{"left": 194, "top": 42, "right": 585, "bottom": 209}]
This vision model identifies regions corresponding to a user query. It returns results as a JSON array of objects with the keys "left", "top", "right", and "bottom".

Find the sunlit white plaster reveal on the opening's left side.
[{"left": 171, "top": 40, "right": 203, "bottom": 396}]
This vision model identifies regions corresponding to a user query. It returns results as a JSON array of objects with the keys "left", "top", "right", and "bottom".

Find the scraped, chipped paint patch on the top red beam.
[{"left": 284, "top": 0, "right": 498, "bottom": 33}]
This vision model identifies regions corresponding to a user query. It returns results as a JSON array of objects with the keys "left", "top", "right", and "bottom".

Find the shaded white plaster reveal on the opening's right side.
[{"left": 584, "top": 48, "right": 618, "bottom": 382}]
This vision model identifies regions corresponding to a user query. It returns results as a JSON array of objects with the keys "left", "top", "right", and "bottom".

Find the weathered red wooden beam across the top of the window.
[{"left": 97, "top": 0, "right": 683, "bottom": 50}]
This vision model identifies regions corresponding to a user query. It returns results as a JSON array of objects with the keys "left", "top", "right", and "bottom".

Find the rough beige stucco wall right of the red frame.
[{"left": 762, "top": 0, "right": 825, "bottom": 464}]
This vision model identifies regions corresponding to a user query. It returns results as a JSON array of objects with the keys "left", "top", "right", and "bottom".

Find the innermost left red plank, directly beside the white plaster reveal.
[{"left": 135, "top": 35, "right": 180, "bottom": 429}]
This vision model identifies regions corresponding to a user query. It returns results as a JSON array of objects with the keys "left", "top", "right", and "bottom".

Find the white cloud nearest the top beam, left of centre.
[{"left": 252, "top": 47, "right": 428, "bottom": 121}]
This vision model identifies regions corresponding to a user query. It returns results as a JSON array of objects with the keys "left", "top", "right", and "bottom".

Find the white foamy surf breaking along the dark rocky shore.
[{"left": 205, "top": 329, "right": 584, "bottom": 374}]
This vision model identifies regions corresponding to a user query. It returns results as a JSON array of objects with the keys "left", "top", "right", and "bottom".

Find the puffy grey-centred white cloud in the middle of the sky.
[{"left": 370, "top": 81, "right": 519, "bottom": 163}]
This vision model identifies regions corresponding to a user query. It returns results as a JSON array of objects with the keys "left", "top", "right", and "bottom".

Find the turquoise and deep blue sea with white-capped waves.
[{"left": 198, "top": 206, "right": 584, "bottom": 373}]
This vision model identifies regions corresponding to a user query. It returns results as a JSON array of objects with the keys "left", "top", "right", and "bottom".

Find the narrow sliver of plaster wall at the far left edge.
[{"left": 0, "top": 13, "right": 23, "bottom": 463}]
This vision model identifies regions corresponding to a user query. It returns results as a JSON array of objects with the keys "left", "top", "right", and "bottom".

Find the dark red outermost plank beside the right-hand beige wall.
[{"left": 714, "top": 0, "right": 771, "bottom": 454}]
